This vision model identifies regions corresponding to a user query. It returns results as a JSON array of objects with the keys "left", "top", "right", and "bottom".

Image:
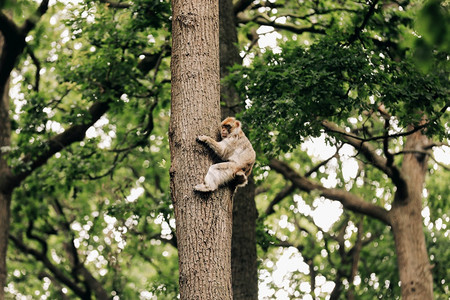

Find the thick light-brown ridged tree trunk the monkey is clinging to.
[{"left": 169, "top": 0, "right": 232, "bottom": 299}]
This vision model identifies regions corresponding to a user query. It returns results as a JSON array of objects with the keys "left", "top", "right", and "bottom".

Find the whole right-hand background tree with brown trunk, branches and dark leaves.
[{"left": 230, "top": 1, "right": 448, "bottom": 299}]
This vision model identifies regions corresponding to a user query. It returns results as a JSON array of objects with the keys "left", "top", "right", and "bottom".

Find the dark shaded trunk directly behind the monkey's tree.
[{"left": 219, "top": 0, "right": 258, "bottom": 300}]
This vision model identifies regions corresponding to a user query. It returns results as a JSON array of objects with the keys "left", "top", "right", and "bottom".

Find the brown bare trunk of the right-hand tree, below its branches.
[{"left": 389, "top": 132, "right": 433, "bottom": 300}]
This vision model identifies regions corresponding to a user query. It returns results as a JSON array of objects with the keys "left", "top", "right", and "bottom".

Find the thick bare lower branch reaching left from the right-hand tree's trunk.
[{"left": 269, "top": 159, "right": 391, "bottom": 225}]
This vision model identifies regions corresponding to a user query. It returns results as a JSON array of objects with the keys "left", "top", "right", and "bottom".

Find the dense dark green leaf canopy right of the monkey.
[{"left": 231, "top": 36, "right": 449, "bottom": 153}]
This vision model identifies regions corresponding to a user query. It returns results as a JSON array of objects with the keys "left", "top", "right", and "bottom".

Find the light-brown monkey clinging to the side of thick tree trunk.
[{"left": 194, "top": 117, "right": 256, "bottom": 192}]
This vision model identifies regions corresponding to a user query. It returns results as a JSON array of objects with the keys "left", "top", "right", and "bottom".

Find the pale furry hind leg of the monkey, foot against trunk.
[{"left": 194, "top": 162, "right": 234, "bottom": 192}]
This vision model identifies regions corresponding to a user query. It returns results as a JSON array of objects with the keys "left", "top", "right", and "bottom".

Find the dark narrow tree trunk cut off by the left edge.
[{"left": 0, "top": 33, "right": 11, "bottom": 300}]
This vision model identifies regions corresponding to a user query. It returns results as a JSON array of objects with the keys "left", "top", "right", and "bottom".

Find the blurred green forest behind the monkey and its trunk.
[{"left": 0, "top": 0, "right": 450, "bottom": 299}]
